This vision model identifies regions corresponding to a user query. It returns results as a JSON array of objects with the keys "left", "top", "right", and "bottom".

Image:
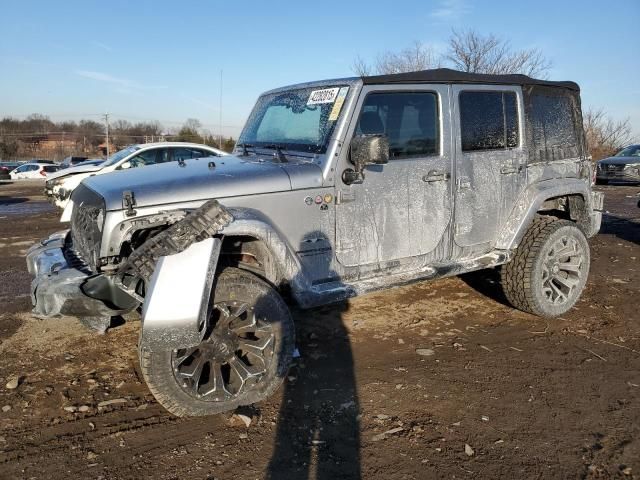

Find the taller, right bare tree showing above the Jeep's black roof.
[{"left": 445, "top": 30, "right": 551, "bottom": 78}]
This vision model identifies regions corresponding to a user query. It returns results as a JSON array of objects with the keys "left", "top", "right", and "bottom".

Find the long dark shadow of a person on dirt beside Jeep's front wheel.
[{"left": 267, "top": 232, "right": 361, "bottom": 480}]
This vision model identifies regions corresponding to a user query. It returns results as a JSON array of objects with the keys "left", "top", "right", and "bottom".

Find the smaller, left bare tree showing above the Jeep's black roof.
[{"left": 351, "top": 41, "right": 441, "bottom": 76}]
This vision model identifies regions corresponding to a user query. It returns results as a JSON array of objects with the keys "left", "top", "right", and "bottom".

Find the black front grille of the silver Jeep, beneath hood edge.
[{"left": 71, "top": 184, "right": 105, "bottom": 272}]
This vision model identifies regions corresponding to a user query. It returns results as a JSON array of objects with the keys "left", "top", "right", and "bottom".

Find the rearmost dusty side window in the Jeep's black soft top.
[{"left": 531, "top": 95, "right": 577, "bottom": 150}]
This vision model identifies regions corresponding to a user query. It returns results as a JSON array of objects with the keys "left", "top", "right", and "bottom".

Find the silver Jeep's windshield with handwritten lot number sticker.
[{"left": 238, "top": 86, "right": 349, "bottom": 153}]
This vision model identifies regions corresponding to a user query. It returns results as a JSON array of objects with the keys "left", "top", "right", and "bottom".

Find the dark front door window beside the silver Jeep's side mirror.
[{"left": 356, "top": 92, "right": 440, "bottom": 160}]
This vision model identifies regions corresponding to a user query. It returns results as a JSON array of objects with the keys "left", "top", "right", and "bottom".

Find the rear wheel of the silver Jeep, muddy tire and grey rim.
[{"left": 502, "top": 216, "right": 590, "bottom": 317}]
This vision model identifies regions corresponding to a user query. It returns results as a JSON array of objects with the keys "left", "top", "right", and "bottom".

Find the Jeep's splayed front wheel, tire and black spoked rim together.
[{"left": 140, "top": 268, "right": 295, "bottom": 416}]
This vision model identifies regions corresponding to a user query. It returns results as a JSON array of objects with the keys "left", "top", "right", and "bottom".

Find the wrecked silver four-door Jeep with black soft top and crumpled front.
[{"left": 27, "top": 69, "right": 603, "bottom": 415}]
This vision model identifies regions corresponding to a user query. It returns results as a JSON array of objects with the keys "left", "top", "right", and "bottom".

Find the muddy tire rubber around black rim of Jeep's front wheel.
[{"left": 139, "top": 268, "right": 295, "bottom": 416}]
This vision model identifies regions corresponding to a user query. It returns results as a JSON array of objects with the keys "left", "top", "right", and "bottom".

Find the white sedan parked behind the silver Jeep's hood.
[{"left": 45, "top": 142, "right": 228, "bottom": 209}]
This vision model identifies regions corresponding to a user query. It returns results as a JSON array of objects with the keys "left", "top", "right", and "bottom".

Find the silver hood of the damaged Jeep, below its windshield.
[{"left": 83, "top": 155, "right": 322, "bottom": 210}]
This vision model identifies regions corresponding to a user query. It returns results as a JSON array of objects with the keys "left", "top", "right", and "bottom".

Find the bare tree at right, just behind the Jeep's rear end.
[{"left": 583, "top": 108, "right": 633, "bottom": 160}]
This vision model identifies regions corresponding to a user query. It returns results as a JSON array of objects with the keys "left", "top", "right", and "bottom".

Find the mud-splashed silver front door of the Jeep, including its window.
[{"left": 336, "top": 85, "right": 451, "bottom": 269}]
